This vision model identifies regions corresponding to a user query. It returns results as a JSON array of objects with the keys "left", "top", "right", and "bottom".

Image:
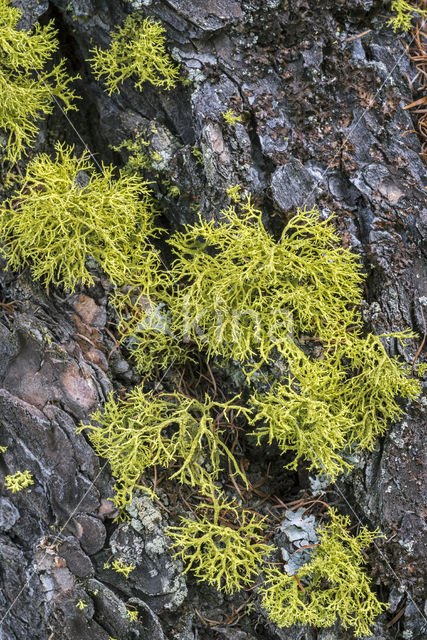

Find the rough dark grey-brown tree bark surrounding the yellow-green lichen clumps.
[{"left": 0, "top": 0, "right": 427, "bottom": 640}]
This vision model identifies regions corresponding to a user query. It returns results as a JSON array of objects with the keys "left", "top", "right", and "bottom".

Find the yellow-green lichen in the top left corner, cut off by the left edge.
[{"left": 0, "top": 0, "right": 76, "bottom": 162}]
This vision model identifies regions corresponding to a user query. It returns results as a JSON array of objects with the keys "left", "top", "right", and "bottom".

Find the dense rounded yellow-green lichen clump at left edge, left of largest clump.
[{"left": 0, "top": 144, "right": 160, "bottom": 291}]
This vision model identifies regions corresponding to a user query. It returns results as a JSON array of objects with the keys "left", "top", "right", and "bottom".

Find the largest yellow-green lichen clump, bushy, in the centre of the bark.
[{"left": 169, "top": 197, "right": 362, "bottom": 372}]
